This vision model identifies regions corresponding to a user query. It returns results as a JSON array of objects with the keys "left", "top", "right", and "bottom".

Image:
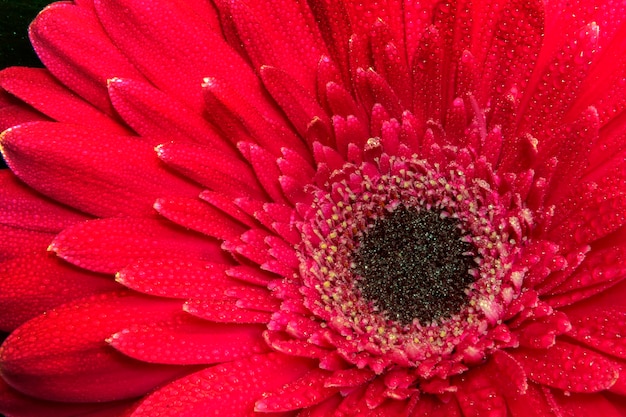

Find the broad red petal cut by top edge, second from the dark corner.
[{"left": 96, "top": 0, "right": 267, "bottom": 114}]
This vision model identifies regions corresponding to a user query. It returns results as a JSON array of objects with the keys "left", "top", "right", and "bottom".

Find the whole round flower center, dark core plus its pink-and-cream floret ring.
[{"left": 284, "top": 153, "right": 532, "bottom": 370}]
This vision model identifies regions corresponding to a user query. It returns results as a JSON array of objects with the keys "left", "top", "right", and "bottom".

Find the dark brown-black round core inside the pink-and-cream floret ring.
[{"left": 353, "top": 207, "right": 476, "bottom": 325}]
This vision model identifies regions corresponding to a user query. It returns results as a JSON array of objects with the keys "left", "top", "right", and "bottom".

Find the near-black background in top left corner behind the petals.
[{"left": 0, "top": 0, "right": 50, "bottom": 408}]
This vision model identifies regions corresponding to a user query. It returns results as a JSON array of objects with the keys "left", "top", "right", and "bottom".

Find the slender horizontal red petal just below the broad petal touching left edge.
[{"left": 50, "top": 218, "right": 226, "bottom": 273}]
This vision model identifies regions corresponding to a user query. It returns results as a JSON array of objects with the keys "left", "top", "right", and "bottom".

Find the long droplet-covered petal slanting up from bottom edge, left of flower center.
[{"left": 132, "top": 353, "right": 312, "bottom": 417}]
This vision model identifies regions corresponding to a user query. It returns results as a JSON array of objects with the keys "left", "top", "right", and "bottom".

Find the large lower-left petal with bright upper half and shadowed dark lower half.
[{"left": 0, "top": 292, "right": 184, "bottom": 402}]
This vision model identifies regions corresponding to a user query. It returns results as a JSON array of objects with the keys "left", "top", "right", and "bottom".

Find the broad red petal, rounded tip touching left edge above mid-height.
[{"left": 1, "top": 122, "right": 200, "bottom": 217}]
